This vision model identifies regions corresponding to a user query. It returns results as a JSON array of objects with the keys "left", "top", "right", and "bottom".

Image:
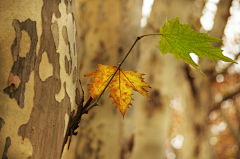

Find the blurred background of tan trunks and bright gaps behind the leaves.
[{"left": 62, "top": 0, "right": 240, "bottom": 159}]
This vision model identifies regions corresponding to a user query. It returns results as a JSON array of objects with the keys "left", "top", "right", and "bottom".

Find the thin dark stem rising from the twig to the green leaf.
[{"left": 86, "top": 34, "right": 161, "bottom": 112}]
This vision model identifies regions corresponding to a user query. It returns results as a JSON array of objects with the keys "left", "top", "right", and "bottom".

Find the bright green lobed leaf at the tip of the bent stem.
[{"left": 159, "top": 17, "right": 236, "bottom": 70}]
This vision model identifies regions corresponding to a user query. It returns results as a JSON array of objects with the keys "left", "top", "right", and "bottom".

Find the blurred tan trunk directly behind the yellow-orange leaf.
[{"left": 63, "top": 0, "right": 142, "bottom": 159}]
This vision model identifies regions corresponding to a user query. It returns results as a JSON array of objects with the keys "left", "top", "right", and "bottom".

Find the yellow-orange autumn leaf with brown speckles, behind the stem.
[{"left": 84, "top": 64, "right": 151, "bottom": 117}]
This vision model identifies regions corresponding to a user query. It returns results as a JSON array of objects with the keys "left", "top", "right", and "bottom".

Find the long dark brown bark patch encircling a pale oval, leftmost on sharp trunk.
[{"left": 4, "top": 19, "right": 38, "bottom": 108}]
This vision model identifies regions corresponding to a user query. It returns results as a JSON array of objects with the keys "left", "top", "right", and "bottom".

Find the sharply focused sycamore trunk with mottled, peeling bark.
[{"left": 0, "top": 0, "right": 79, "bottom": 159}]
